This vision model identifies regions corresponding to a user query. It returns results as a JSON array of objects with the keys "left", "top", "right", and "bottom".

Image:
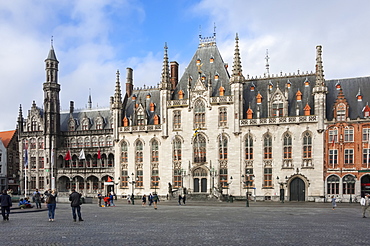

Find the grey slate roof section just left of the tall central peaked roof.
[{"left": 123, "top": 87, "right": 161, "bottom": 125}]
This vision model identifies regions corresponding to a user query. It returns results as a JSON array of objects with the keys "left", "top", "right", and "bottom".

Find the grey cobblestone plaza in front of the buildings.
[{"left": 0, "top": 200, "right": 370, "bottom": 246}]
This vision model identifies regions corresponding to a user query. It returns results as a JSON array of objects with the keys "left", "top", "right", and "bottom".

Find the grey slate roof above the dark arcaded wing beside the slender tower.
[{"left": 60, "top": 108, "right": 112, "bottom": 132}]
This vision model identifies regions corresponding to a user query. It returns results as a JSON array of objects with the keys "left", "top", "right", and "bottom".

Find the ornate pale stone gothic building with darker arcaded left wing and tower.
[{"left": 18, "top": 34, "right": 370, "bottom": 201}]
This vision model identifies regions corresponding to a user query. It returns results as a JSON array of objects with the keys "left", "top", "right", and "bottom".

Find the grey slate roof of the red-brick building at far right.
[{"left": 325, "top": 77, "right": 370, "bottom": 121}]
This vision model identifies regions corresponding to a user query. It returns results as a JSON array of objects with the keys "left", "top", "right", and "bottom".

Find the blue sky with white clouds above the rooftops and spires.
[{"left": 0, "top": 0, "right": 370, "bottom": 131}]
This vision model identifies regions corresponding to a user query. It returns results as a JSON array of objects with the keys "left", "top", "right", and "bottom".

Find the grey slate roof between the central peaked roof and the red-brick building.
[{"left": 243, "top": 74, "right": 316, "bottom": 119}]
